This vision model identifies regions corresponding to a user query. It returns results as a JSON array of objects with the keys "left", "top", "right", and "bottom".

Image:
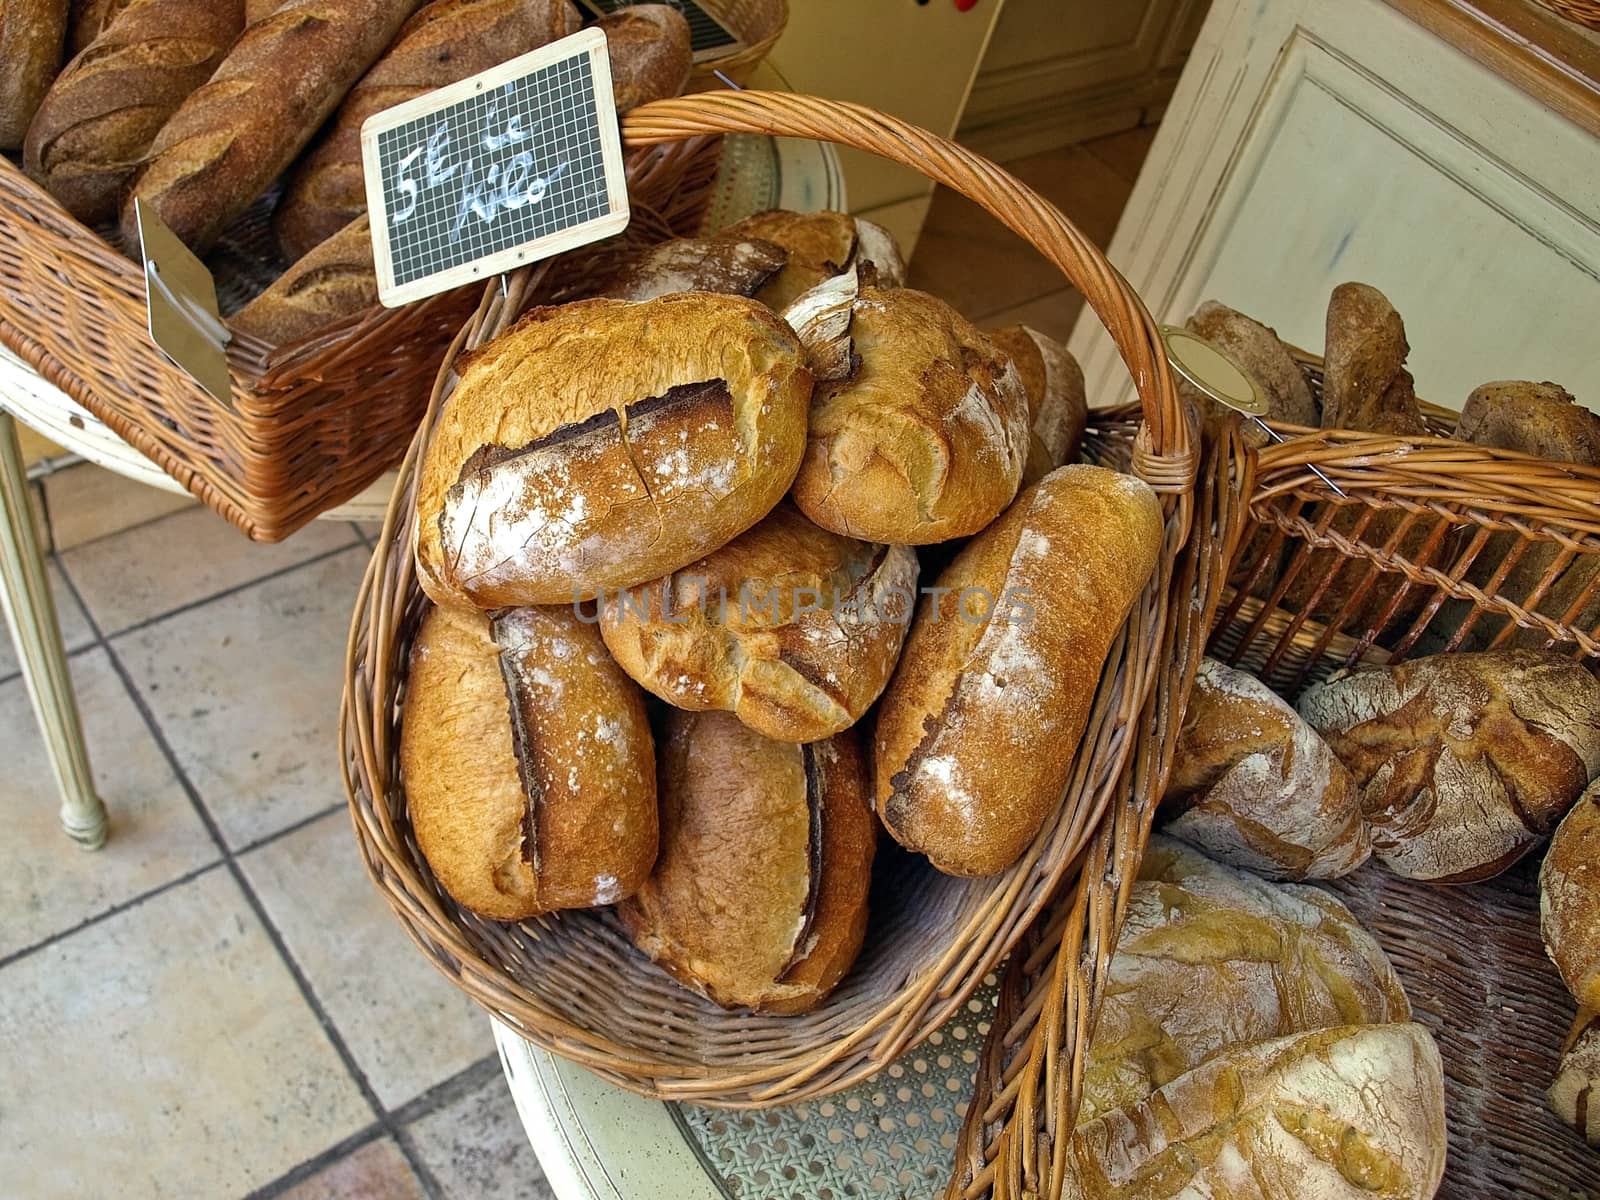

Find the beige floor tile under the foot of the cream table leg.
[{"left": 0, "top": 650, "right": 218, "bottom": 966}]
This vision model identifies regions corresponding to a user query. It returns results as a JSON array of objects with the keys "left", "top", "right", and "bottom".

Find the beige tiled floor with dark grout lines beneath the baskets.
[{"left": 0, "top": 131, "right": 1149, "bottom": 1200}]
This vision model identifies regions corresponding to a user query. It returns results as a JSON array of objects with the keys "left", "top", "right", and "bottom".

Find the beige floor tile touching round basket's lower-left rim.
[{"left": 240, "top": 811, "right": 494, "bottom": 1109}]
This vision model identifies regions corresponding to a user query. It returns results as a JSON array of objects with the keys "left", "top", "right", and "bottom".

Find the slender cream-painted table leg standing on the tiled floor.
[{"left": 0, "top": 408, "right": 106, "bottom": 850}]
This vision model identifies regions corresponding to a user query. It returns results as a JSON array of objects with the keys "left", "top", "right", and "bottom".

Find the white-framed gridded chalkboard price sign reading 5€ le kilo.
[{"left": 362, "top": 29, "right": 629, "bottom": 307}]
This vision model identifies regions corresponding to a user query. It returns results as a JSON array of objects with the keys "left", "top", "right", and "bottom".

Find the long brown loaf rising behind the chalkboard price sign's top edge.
[{"left": 272, "top": 0, "right": 579, "bottom": 259}]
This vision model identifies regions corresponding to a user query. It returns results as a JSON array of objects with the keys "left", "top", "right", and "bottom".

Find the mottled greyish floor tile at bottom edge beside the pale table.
[{"left": 408, "top": 1070, "right": 555, "bottom": 1200}]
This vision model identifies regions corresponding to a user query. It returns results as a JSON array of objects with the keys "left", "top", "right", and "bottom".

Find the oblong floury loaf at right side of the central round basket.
[{"left": 875, "top": 466, "right": 1162, "bottom": 875}]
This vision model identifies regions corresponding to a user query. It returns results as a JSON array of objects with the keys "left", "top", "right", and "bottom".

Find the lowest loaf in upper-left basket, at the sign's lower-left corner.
[{"left": 229, "top": 213, "right": 378, "bottom": 346}]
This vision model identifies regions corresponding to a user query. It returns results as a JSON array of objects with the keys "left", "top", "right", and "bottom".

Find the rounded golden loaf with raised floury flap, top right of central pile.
[{"left": 784, "top": 270, "right": 1027, "bottom": 546}]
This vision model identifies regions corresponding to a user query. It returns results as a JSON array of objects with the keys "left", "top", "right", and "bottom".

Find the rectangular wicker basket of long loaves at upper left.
[{"left": 0, "top": 138, "right": 720, "bottom": 541}]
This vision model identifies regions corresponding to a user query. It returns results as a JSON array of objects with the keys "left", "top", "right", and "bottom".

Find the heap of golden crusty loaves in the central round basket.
[{"left": 390, "top": 211, "right": 1163, "bottom": 1013}]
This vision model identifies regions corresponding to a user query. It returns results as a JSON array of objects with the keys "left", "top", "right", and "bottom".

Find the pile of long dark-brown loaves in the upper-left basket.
[{"left": 0, "top": 0, "right": 693, "bottom": 346}]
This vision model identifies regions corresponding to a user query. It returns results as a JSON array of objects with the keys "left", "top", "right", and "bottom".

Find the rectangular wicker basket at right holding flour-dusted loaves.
[{"left": 957, "top": 358, "right": 1600, "bottom": 1200}]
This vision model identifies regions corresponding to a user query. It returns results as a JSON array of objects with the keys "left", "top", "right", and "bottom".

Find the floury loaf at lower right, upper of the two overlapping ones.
[{"left": 1078, "top": 835, "right": 1411, "bottom": 1123}]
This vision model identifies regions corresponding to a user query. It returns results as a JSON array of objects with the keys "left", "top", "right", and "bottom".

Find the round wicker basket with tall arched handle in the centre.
[{"left": 342, "top": 93, "right": 1194, "bottom": 1106}]
